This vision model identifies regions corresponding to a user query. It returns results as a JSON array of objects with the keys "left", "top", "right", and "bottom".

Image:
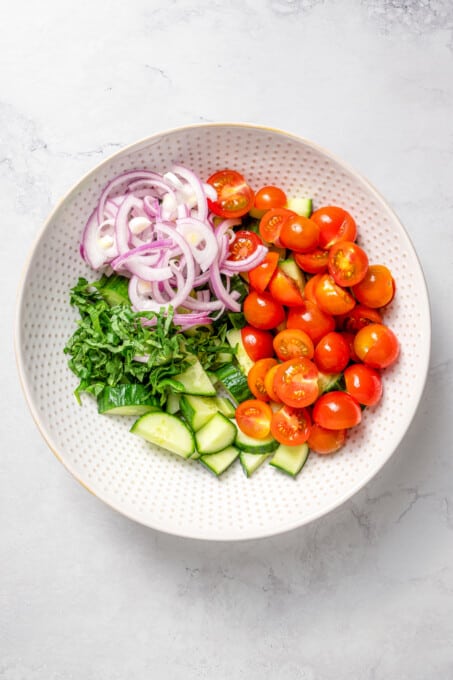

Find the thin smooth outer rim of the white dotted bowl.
[{"left": 13, "top": 121, "right": 432, "bottom": 542}]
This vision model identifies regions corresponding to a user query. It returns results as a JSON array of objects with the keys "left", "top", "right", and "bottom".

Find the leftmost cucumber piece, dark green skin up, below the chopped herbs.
[{"left": 97, "top": 384, "right": 160, "bottom": 416}]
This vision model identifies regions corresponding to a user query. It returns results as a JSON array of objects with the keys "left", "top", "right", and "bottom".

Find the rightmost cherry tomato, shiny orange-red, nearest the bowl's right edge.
[{"left": 354, "top": 323, "right": 399, "bottom": 368}]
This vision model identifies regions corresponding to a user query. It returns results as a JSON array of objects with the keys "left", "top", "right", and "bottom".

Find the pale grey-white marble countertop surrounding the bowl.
[{"left": 0, "top": 0, "right": 453, "bottom": 680}]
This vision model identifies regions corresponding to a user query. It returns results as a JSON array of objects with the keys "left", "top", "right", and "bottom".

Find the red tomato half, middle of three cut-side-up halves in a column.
[{"left": 274, "top": 357, "right": 319, "bottom": 408}]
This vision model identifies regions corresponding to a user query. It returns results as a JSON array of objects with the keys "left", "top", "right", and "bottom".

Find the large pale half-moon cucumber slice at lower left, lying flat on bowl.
[{"left": 131, "top": 412, "right": 195, "bottom": 458}]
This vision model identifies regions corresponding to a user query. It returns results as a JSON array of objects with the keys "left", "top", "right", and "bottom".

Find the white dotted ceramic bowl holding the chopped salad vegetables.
[{"left": 16, "top": 124, "right": 430, "bottom": 540}]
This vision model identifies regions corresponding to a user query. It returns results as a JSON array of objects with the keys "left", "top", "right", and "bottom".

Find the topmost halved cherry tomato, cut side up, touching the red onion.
[{"left": 207, "top": 170, "right": 254, "bottom": 218}]
